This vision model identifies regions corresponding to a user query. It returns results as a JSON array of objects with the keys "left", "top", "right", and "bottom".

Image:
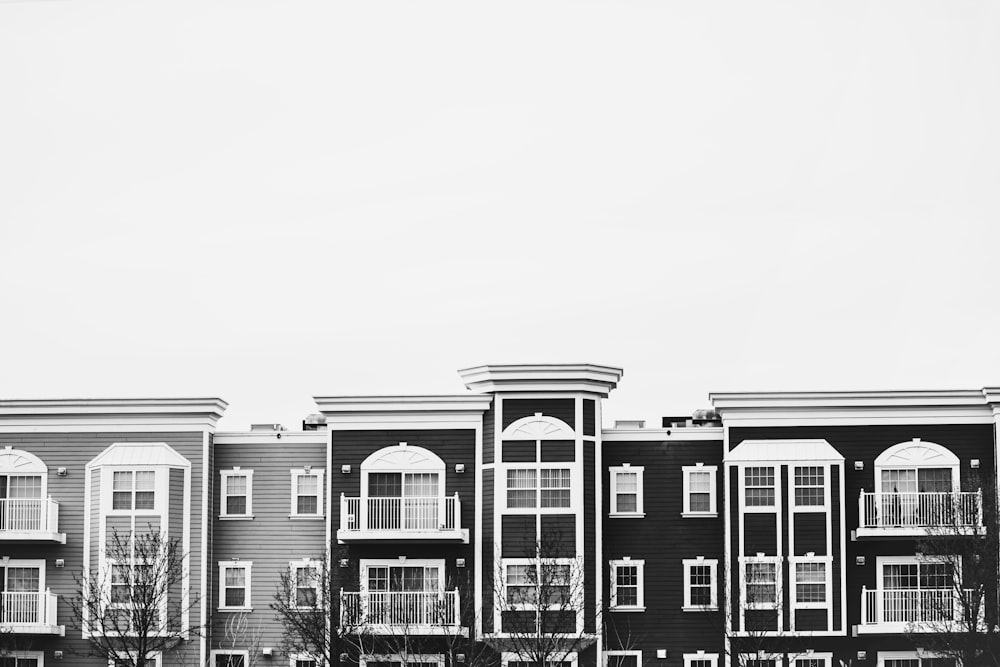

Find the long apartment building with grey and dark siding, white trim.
[{"left": 0, "top": 364, "right": 1000, "bottom": 667}]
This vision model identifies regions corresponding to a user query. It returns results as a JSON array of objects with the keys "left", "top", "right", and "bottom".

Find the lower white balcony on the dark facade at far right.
[{"left": 858, "top": 588, "right": 974, "bottom": 634}]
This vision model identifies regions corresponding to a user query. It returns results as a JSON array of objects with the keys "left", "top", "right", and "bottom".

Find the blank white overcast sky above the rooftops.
[{"left": 0, "top": 0, "right": 1000, "bottom": 429}]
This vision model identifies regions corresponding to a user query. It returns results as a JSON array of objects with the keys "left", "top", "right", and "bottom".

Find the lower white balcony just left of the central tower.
[{"left": 340, "top": 589, "right": 466, "bottom": 635}]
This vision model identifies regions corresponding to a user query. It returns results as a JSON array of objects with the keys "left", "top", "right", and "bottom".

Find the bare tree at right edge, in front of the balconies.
[{"left": 900, "top": 484, "right": 1000, "bottom": 667}]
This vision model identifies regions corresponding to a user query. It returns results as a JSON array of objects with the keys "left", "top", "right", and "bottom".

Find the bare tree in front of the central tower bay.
[{"left": 486, "top": 535, "right": 601, "bottom": 667}]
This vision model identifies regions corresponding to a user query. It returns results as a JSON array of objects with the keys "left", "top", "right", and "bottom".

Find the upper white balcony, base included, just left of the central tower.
[{"left": 337, "top": 493, "right": 469, "bottom": 544}]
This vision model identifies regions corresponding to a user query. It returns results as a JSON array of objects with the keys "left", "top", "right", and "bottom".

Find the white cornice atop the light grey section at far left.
[{"left": 0, "top": 398, "right": 228, "bottom": 433}]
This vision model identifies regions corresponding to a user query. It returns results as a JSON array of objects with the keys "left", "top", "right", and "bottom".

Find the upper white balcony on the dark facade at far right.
[{"left": 857, "top": 491, "right": 983, "bottom": 538}]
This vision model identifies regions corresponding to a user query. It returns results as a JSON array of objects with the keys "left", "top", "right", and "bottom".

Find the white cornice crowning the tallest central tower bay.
[{"left": 458, "top": 364, "right": 622, "bottom": 396}]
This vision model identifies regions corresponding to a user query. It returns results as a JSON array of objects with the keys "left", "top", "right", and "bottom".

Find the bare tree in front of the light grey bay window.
[{"left": 70, "top": 527, "right": 201, "bottom": 667}]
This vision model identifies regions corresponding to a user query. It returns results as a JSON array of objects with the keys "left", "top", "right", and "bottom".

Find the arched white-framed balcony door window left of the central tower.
[{"left": 361, "top": 442, "right": 446, "bottom": 530}]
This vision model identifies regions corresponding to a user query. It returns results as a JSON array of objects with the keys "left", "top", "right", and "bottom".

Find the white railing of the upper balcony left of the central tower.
[{"left": 340, "top": 493, "right": 462, "bottom": 533}]
